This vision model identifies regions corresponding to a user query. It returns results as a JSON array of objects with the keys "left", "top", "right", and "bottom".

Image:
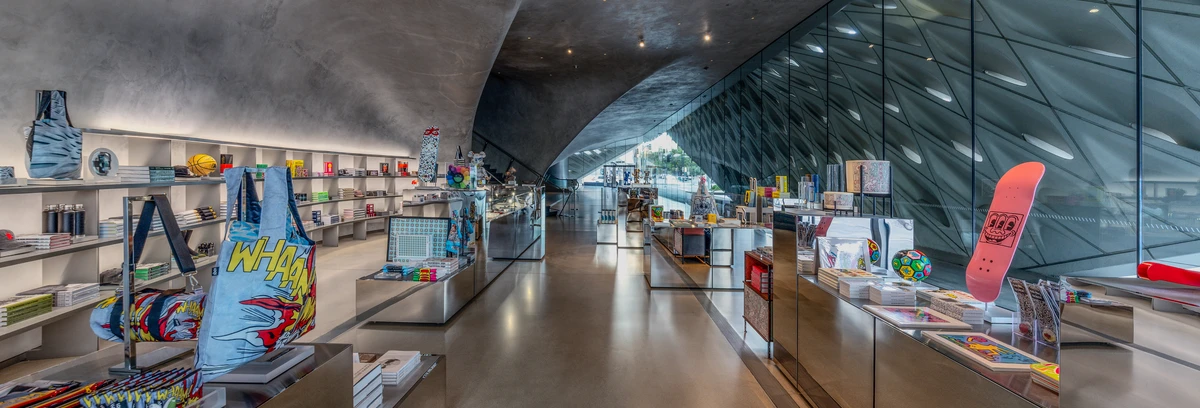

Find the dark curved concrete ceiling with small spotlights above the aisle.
[{"left": 475, "top": 0, "right": 827, "bottom": 178}]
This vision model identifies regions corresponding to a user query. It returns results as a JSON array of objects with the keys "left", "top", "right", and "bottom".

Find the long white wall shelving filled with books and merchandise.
[{"left": 0, "top": 130, "right": 416, "bottom": 361}]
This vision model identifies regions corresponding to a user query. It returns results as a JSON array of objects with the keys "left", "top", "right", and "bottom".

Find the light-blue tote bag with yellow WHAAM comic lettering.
[{"left": 196, "top": 167, "right": 317, "bottom": 382}]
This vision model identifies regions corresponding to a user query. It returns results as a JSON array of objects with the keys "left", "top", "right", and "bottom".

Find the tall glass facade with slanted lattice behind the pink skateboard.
[{"left": 647, "top": 0, "right": 1200, "bottom": 300}]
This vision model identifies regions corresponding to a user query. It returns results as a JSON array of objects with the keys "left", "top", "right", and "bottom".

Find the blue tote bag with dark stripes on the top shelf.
[{"left": 25, "top": 91, "right": 83, "bottom": 180}]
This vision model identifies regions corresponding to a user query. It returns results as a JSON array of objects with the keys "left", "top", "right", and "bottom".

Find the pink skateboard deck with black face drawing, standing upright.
[{"left": 967, "top": 162, "right": 1046, "bottom": 302}]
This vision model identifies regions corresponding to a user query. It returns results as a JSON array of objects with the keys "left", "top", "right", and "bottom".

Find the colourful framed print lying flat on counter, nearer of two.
[{"left": 922, "top": 331, "right": 1046, "bottom": 372}]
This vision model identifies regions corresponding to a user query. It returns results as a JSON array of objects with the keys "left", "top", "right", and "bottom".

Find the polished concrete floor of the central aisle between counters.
[{"left": 308, "top": 190, "right": 803, "bottom": 407}]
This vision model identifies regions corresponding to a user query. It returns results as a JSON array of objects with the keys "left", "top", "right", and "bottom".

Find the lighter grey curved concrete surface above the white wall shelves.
[{"left": 0, "top": 0, "right": 520, "bottom": 164}]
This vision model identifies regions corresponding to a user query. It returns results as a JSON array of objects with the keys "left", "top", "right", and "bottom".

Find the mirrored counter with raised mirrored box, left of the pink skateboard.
[{"left": 772, "top": 212, "right": 1058, "bottom": 408}]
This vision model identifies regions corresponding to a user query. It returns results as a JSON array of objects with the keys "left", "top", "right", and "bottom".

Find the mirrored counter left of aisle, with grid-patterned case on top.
[{"left": 355, "top": 186, "right": 545, "bottom": 324}]
